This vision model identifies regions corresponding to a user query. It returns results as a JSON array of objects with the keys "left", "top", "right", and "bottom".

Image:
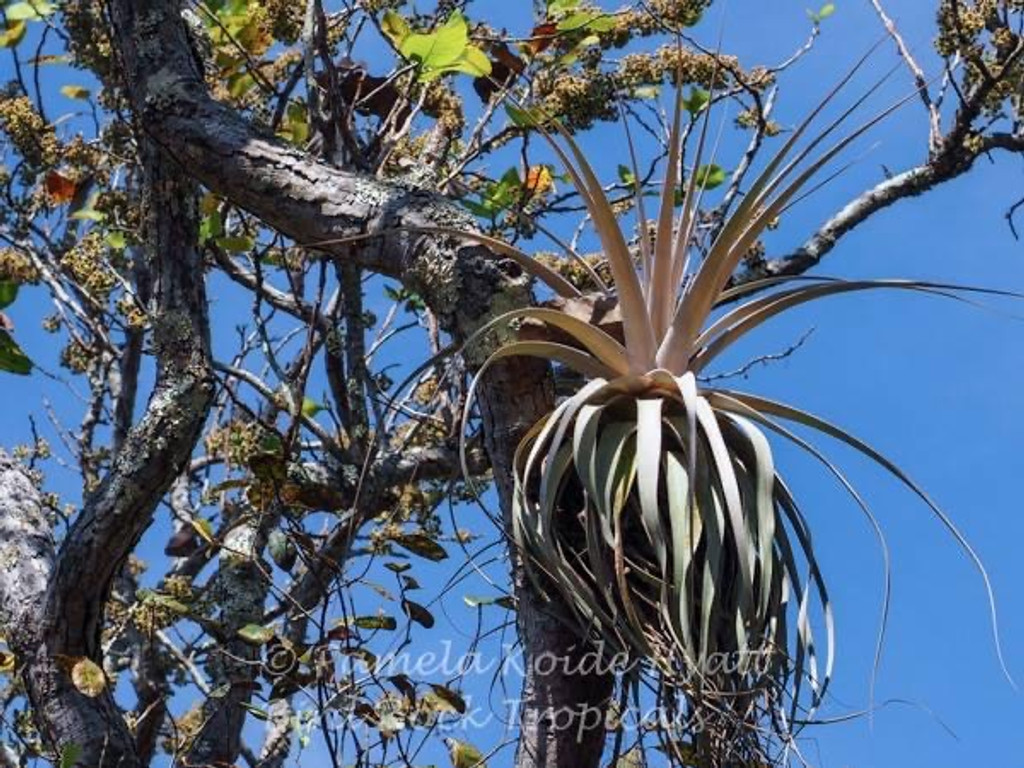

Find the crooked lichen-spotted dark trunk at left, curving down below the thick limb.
[{"left": 3, "top": 135, "right": 213, "bottom": 767}]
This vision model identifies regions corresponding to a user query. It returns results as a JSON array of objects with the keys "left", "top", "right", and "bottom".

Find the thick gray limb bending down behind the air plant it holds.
[{"left": 101, "top": 0, "right": 611, "bottom": 767}]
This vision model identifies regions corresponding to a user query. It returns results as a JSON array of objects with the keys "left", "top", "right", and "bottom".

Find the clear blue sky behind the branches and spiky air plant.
[{"left": 0, "top": 0, "right": 1024, "bottom": 768}]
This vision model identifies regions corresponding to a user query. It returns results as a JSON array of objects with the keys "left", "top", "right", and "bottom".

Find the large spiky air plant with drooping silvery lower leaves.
[{"left": 454, "top": 49, "right": 1006, "bottom": 765}]
